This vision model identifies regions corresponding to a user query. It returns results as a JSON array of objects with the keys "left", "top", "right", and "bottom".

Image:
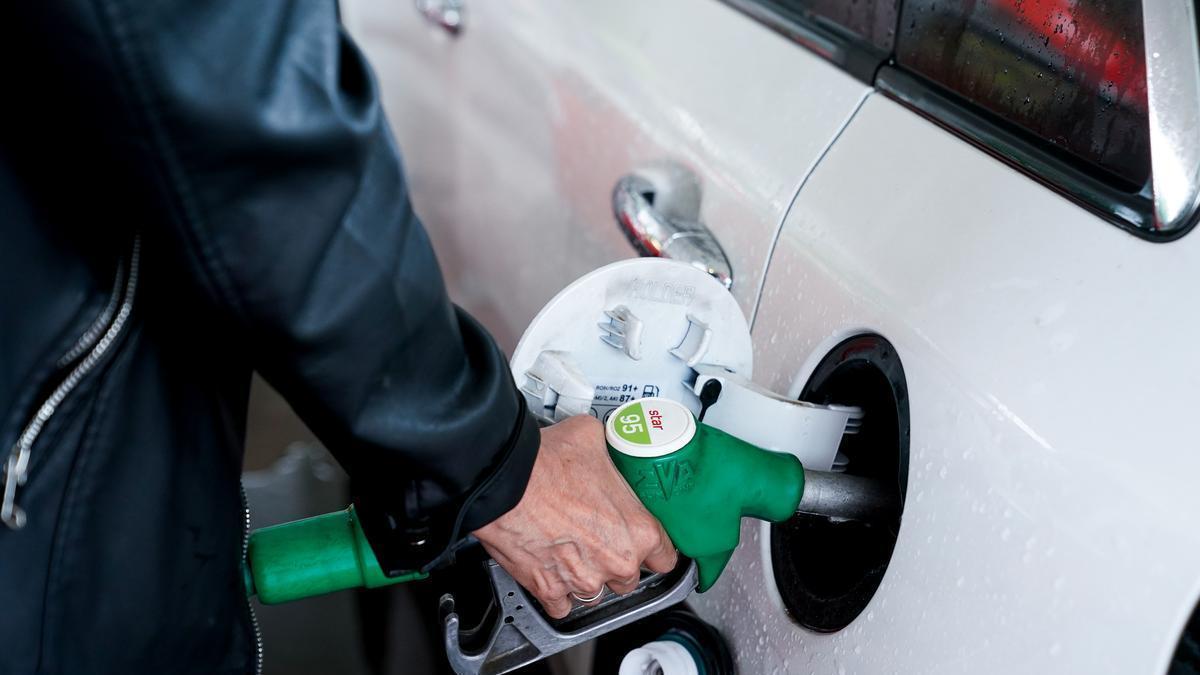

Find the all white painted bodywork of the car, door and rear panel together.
[{"left": 343, "top": 0, "right": 1200, "bottom": 674}]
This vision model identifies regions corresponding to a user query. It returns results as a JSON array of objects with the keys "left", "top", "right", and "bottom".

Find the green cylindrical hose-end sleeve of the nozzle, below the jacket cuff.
[{"left": 244, "top": 506, "right": 427, "bottom": 604}]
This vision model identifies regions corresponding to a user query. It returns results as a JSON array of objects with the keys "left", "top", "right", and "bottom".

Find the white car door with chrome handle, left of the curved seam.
[{"left": 343, "top": 0, "right": 868, "bottom": 350}]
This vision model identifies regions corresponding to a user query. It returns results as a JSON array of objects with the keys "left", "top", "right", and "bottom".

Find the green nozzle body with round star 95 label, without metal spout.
[{"left": 605, "top": 398, "right": 804, "bottom": 592}]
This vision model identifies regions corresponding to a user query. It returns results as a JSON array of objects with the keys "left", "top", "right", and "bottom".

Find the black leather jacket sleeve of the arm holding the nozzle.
[{"left": 28, "top": 0, "right": 539, "bottom": 572}]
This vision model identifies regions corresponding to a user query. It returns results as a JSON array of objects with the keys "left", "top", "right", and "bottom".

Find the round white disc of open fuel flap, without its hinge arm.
[{"left": 511, "top": 258, "right": 754, "bottom": 422}]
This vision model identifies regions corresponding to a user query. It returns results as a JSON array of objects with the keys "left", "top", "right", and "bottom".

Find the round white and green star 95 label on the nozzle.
[{"left": 605, "top": 398, "right": 696, "bottom": 458}]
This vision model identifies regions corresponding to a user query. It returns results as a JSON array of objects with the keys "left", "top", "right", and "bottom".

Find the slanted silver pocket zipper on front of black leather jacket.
[{"left": 0, "top": 237, "right": 142, "bottom": 530}]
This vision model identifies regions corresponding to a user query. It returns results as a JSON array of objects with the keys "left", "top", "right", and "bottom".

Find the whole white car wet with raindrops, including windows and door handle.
[{"left": 343, "top": 0, "right": 1200, "bottom": 675}]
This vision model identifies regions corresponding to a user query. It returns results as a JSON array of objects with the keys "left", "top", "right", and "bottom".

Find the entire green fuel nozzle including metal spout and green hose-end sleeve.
[{"left": 245, "top": 398, "right": 844, "bottom": 604}]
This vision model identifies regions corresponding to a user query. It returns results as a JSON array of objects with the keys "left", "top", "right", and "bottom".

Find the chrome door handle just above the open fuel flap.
[{"left": 612, "top": 166, "right": 733, "bottom": 288}]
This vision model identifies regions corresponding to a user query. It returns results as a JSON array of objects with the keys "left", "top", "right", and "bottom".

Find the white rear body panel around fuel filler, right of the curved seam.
[{"left": 710, "top": 95, "right": 1200, "bottom": 674}]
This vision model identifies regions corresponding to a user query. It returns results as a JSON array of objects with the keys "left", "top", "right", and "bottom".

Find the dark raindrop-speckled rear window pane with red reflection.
[{"left": 895, "top": 0, "right": 1150, "bottom": 191}]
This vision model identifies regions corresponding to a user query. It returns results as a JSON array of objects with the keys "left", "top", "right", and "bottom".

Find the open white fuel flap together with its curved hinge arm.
[{"left": 511, "top": 258, "right": 858, "bottom": 471}]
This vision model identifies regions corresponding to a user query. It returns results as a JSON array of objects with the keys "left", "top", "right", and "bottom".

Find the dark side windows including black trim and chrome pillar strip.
[{"left": 722, "top": 0, "right": 1200, "bottom": 235}]
